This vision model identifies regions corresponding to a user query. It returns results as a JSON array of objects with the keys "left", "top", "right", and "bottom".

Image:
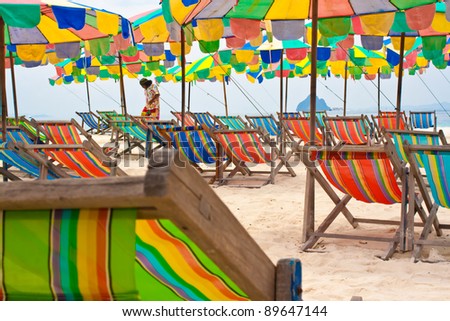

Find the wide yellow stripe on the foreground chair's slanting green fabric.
[{"left": 136, "top": 224, "right": 226, "bottom": 300}]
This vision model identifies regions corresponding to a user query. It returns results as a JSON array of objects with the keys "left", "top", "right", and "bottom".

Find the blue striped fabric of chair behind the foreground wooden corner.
[{"left": 167, "top": 128, "right": 217, "bottom": 164}]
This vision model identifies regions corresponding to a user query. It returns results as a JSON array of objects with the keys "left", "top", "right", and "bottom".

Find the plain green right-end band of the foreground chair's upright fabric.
[{"left": 109, "top": 209, "right": 138, "bottom": 300}]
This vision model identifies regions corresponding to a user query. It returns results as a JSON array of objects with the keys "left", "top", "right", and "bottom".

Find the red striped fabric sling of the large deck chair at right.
[{"left": 316, "top": 152, "right": 402, "bottom": 204}]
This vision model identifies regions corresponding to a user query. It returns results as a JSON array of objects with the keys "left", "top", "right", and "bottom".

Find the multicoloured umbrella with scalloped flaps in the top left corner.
[{"left": 0, "top": 0, "right": 132, "bottom": 135}]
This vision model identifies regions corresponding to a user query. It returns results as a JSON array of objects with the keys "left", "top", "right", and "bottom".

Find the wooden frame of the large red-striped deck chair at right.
[{"left": 298, "top": 145, "right": 416, "bottom": 260}]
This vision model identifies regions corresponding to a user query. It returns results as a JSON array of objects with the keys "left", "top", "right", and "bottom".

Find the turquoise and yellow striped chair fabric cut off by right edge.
[{"left": 418, "top": 149, "right": 450, "bottom": 208}]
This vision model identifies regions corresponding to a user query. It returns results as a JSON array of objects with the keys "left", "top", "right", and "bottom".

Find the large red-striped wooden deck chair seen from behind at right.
[{"left": 298, "top": 145, "right": 414, "bottom": 259}]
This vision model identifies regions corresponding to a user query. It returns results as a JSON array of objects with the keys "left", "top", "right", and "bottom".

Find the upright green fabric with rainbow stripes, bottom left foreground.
[{"left": 0, "top": 209, "right": 138, "bottom": 300}]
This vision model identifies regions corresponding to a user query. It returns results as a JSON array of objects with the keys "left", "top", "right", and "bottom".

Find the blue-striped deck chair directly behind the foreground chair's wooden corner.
[{"left": 158, "top": 126, "right": 224, "bottom": 184}]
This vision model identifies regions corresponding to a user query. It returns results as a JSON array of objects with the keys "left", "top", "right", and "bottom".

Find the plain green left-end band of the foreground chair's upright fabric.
[{"left": 4, "top": 211, "right": 53, "bottom": 301}]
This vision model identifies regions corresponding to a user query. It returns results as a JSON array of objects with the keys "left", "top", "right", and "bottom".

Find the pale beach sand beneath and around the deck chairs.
[{"left": 103, "top": 128, "right": 450, "bottom": 301}]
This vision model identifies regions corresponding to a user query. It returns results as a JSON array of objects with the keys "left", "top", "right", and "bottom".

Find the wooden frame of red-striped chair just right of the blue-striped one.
[{"left": 203, "top": 126, "right": 296, "bottom": 185}]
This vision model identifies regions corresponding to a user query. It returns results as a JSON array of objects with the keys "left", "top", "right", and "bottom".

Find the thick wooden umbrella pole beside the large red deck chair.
[{"left": 302, "top": 0, "right": 325, "bottom": 242}]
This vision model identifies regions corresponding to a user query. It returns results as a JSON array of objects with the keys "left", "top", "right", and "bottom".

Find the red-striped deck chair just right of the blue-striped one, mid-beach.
[{"left": 204, "top": 127, "right": 296, "bottom": 185}]
